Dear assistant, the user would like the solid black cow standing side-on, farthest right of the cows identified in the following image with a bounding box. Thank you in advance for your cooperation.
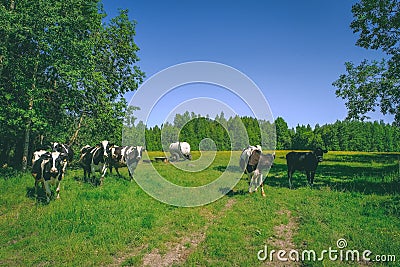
[286,148,328,188]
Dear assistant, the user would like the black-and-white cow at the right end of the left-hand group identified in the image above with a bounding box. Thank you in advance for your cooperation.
[109,146,144,181]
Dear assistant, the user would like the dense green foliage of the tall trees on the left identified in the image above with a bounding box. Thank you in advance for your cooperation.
[0,0,144,168]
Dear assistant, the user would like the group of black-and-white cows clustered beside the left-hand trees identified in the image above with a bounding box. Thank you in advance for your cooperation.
[31,140,144,202]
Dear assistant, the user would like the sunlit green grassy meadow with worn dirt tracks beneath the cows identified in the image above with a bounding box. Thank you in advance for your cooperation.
[0,151,400,266]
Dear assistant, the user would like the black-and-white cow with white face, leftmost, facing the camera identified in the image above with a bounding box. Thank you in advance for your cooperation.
[32,151,62,203]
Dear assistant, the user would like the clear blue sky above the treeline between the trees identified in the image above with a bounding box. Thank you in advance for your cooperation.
[103,0,393,130]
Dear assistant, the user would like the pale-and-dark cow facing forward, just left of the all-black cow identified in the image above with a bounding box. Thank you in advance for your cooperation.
[239,146,275,197]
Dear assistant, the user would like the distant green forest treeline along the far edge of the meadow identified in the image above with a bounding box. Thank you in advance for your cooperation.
[123,112,400,152]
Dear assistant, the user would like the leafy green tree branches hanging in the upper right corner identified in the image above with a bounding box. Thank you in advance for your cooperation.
[333,0,400,125]
